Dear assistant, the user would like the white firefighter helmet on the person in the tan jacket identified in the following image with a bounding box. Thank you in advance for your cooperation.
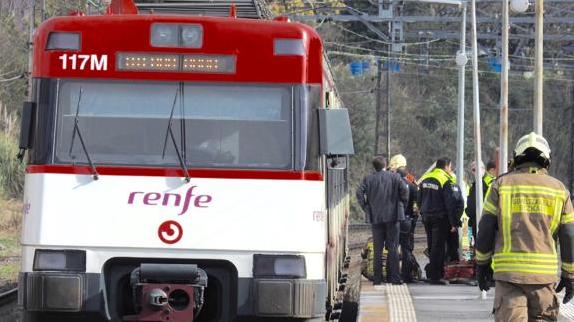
[514,132,550,168]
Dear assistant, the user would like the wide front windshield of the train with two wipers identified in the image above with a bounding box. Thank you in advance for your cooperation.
[54,80,294,169]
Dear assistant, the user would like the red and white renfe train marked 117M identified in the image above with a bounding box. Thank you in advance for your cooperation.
[19,0,353,322]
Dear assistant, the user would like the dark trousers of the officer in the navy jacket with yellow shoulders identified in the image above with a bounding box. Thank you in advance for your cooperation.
[425,217,450,280]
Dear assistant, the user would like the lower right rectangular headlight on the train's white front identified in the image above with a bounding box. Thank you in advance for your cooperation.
[253,254,307,278]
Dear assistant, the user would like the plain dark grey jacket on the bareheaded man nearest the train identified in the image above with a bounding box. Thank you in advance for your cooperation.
[357,171,409,224]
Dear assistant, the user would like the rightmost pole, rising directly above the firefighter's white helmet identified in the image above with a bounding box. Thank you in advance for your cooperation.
[534,0,544,135]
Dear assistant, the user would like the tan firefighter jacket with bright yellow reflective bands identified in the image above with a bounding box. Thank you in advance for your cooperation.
[476,164,574,284]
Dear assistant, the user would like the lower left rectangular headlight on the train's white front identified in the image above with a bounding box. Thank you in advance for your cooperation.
[34,249,86,272]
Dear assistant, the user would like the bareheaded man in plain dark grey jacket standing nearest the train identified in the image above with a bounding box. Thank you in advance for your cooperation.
[357,156,409,285]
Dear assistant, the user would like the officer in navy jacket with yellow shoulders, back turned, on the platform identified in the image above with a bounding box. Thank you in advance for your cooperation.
[418,158,464,284]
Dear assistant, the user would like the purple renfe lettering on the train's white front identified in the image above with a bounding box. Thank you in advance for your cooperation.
[128,186,213,215]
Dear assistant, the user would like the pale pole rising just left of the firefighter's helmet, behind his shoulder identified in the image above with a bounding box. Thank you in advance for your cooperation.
[498,0,510,173]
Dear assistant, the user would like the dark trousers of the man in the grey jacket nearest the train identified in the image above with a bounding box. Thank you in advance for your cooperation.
[372,222,400,284]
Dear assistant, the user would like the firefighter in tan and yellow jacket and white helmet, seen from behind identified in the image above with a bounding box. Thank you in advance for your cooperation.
[476,133,574,322]
